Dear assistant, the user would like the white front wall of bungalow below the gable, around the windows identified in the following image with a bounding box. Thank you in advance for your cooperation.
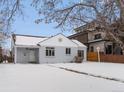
[39,47,87,64]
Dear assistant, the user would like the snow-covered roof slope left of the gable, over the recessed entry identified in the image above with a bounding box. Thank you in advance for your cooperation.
[15,35,47,46]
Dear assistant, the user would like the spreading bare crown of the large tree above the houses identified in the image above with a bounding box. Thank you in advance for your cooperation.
[32,0,119,27]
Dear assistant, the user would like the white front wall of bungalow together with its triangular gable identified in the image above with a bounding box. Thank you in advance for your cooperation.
[39,34,86,63]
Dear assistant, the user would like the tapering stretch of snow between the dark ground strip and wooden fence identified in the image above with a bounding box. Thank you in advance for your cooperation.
[52,62,124,83]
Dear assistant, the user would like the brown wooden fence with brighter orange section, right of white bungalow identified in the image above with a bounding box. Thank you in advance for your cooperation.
[87,52,124,63]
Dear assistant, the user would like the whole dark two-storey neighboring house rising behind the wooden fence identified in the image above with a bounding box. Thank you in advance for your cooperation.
[68,24,124,54]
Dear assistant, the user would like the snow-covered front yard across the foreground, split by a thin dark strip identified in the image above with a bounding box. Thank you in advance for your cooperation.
[0,63,124,92]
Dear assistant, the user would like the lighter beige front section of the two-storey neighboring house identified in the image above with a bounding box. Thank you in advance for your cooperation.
[88,31,114,54]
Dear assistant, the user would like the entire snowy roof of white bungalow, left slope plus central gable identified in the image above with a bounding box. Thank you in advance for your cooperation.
[15,33,86,47]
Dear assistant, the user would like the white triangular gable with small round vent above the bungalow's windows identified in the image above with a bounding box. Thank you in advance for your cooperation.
[39,33,86,47]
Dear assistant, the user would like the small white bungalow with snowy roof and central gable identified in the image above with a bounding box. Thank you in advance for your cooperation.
[12,34,87,64]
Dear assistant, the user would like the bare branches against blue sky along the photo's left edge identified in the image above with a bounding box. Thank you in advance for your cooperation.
[0,0,23,48]
